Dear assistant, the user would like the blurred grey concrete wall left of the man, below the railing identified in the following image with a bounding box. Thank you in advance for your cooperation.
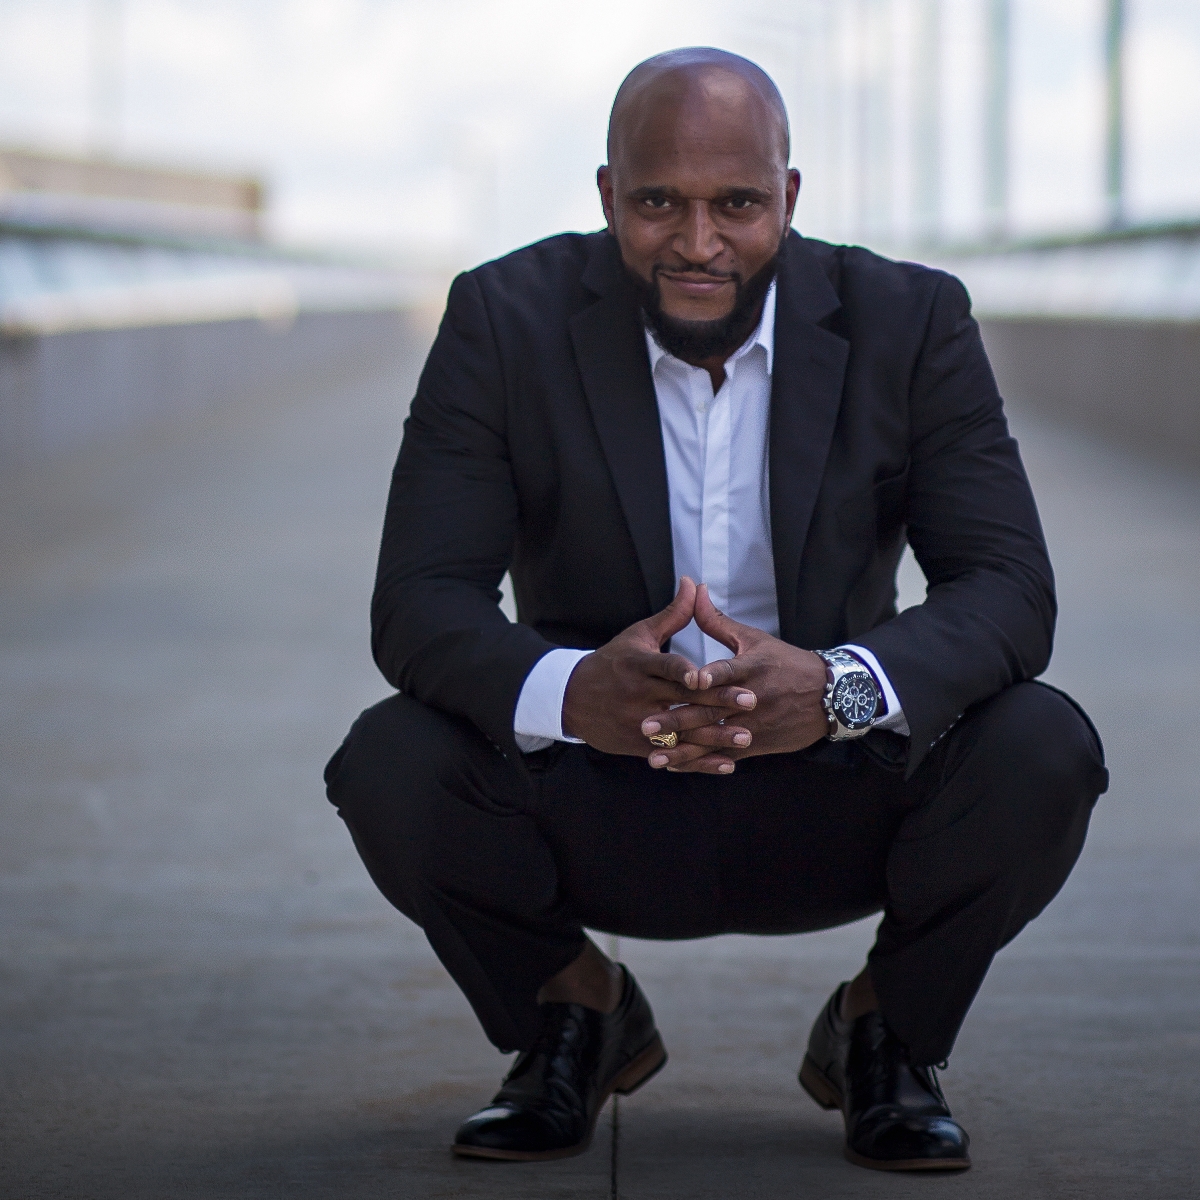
[0,312,417,469]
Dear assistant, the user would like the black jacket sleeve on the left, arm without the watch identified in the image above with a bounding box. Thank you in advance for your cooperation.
[371,275,553,760]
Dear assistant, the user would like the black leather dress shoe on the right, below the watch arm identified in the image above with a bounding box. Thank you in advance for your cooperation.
[800,984,971,1171]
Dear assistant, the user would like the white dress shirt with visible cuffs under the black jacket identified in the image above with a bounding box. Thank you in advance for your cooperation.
[512,283,908,754]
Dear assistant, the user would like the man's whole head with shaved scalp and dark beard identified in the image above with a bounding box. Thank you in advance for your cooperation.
[596,48,800,355]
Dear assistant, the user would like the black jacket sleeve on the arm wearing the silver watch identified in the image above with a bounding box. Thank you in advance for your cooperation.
[856,276,1057,774]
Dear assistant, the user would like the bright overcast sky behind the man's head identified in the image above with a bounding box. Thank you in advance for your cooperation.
[0,0,1200,266]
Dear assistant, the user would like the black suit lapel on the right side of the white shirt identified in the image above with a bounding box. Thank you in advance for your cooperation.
[769,234,850,641]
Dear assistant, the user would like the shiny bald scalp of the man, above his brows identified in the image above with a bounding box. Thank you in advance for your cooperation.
[608,46,791,168]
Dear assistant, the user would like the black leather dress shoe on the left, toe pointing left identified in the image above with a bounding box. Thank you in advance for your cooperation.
[452,966,667,1162]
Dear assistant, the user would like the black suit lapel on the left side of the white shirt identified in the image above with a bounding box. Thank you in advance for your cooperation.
[569,236,674,612]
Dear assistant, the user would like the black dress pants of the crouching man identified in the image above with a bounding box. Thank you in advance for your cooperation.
[325,683,1108,1063]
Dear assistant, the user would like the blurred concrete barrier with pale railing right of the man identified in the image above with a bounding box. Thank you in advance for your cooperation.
[935,223,1200,469]
